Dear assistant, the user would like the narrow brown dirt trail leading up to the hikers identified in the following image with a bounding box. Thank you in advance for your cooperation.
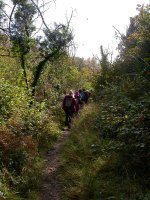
[41,131,69,200]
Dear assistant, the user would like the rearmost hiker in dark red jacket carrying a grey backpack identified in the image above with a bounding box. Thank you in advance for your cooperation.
[62,90,76,128]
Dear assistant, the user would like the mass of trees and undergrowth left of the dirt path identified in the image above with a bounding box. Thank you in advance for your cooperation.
[0,0,95,200]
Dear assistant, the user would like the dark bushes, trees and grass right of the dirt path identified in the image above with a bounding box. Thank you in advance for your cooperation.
[60,5,150,200]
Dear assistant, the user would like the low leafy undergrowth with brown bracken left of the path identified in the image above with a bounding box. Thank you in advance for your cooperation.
[0,80,60,200]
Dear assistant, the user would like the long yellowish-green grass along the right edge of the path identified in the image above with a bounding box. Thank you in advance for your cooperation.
[59,105,150,200]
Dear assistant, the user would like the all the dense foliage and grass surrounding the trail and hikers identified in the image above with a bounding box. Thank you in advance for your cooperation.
[0,0,150,200]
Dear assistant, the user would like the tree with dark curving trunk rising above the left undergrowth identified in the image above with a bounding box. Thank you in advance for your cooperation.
[0,0,73,96]
